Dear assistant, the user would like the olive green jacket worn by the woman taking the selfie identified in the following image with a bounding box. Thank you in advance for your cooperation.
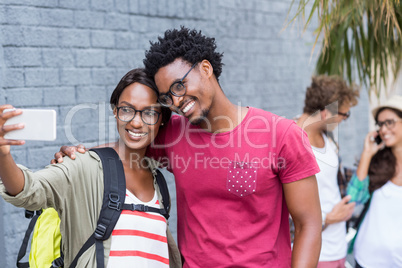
[0,151,181,267]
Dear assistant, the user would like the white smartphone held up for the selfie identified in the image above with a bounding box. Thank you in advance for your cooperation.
[4,109,56,141]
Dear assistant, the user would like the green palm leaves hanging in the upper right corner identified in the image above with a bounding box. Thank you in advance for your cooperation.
[291,0,402,96]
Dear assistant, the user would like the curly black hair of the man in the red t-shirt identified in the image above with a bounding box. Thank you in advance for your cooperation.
[143,26,223,80]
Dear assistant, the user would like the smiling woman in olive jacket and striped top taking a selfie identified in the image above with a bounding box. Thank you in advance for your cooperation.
[0,69,181,267]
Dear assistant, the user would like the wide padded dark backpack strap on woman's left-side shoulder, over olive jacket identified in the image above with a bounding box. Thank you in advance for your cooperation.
[70,147,126,268]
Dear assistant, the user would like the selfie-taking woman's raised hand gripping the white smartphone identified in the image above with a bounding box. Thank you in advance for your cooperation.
[0,104,25,155]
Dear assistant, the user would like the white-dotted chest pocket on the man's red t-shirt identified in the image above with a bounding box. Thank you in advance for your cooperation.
[226,161,258,197]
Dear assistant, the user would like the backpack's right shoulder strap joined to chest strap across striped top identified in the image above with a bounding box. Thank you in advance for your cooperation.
[122,169,170,220]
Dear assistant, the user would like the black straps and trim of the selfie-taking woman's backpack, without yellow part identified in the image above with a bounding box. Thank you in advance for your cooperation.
[17,147,170,268]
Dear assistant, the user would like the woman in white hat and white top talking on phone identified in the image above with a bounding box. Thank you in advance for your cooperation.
[348,96,402,268]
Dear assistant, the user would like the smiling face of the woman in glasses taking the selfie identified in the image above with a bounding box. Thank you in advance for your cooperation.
[113,82,162,153]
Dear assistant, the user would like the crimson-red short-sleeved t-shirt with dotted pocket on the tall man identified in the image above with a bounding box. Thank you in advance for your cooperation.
[149,107,319,268]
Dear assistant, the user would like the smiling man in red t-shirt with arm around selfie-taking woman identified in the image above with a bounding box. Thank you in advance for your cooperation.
[55,27,321,268]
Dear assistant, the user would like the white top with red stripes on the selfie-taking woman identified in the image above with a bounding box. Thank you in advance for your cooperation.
[107,190,169,268]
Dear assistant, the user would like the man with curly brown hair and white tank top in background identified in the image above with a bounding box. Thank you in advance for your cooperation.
[297,75,359,268]
